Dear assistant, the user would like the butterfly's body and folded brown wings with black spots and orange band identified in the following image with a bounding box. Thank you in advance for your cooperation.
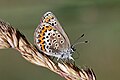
[34,12,74,60]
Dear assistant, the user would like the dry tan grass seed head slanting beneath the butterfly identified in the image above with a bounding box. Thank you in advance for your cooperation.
[0,20,96,80]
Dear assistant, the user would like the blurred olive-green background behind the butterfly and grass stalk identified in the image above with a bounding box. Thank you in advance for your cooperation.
[0,0,120,80]
